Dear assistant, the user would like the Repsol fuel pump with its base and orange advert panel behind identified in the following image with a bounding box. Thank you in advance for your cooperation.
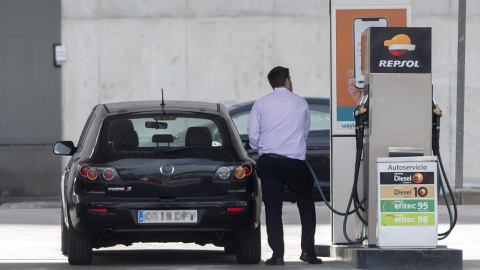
[322,0,462,269]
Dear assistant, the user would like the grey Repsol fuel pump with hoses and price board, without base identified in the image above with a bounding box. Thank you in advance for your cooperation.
[310,27,457,247]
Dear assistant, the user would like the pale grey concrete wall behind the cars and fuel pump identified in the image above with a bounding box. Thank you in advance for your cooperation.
[62,0,480,186]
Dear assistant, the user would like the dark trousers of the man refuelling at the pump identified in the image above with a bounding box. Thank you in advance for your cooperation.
[257,155,316,258]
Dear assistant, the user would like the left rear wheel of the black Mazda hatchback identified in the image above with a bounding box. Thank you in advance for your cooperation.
[68,223,92,265]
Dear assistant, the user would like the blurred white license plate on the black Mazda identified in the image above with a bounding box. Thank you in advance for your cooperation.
[138,210,197,223]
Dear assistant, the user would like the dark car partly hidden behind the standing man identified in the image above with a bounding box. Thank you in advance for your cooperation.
[229,98,330,202]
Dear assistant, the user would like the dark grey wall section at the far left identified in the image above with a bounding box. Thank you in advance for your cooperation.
[0,0,63,199]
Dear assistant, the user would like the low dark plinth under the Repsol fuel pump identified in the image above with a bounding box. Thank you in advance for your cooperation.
[330,245,463,270]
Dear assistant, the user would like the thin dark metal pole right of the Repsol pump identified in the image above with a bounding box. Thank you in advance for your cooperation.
[455,0,467,188]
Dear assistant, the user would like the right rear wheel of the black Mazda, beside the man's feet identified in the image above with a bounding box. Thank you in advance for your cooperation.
[237,225,262,264]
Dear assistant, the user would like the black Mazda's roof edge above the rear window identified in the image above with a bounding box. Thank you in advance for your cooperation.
[103,100,226,113]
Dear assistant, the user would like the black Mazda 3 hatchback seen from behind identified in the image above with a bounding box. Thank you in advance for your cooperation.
[53,101,262,264]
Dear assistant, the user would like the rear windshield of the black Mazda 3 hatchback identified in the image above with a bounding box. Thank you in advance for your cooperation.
[100,113,229,158]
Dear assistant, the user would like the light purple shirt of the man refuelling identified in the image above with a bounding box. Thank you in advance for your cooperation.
[248,88,310,160]
